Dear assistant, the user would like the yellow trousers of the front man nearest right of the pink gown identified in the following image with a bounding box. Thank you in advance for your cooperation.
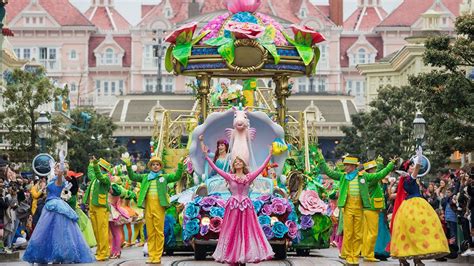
[341,195,363,264]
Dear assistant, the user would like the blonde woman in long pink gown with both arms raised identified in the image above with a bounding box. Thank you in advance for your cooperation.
[206,143,275,264]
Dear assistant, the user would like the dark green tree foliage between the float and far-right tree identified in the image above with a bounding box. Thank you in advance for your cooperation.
[337,86,417,161]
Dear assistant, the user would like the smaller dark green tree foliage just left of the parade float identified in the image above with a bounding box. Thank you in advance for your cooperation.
[67,108,126,173]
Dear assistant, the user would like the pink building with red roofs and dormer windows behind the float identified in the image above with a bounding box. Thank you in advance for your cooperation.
[3,0,463,112]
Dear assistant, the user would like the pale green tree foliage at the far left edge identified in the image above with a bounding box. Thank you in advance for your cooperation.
[0,67,64,158]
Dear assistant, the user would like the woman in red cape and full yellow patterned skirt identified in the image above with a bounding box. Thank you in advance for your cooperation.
[390,147,449,266]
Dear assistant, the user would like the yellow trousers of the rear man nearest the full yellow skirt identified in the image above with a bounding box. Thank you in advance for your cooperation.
[362,210,380,259]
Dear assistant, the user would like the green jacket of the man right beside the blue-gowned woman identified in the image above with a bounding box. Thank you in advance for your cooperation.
[84,164,110,208]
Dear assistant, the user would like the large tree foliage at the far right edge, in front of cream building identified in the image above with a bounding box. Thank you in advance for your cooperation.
[410,15,474,166]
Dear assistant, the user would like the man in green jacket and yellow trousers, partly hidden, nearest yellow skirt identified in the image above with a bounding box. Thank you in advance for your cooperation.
[362,158,385,262]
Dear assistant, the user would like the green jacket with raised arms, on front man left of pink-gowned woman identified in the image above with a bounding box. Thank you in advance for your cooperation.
[127,162,184,209]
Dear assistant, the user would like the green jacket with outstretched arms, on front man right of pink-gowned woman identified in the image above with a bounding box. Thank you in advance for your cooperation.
[316,155,393,208]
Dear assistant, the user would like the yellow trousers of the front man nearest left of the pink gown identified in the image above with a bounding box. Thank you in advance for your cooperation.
[145,195,165,263]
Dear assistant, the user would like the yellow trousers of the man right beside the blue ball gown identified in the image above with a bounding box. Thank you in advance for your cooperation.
[89,204,110,261]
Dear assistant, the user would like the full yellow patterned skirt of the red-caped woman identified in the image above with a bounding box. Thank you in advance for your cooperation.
[390,197,449,259]
